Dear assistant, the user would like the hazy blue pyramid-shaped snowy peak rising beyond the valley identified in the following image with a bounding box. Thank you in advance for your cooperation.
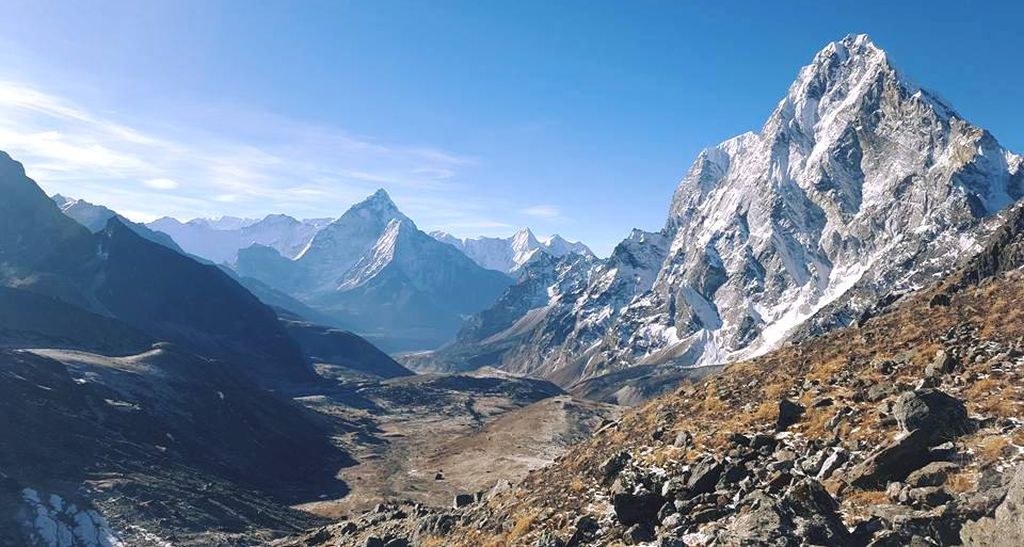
[236,190,511,350]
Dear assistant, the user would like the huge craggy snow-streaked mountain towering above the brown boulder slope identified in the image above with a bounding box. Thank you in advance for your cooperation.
[415,35,1024,391]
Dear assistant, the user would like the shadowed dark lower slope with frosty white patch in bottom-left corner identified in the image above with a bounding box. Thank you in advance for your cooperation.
[0,344,351,547]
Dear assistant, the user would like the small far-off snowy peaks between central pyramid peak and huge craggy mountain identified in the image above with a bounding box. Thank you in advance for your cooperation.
[430,227,594,274]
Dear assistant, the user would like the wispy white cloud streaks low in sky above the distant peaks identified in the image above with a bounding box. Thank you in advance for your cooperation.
[0,81,520,235]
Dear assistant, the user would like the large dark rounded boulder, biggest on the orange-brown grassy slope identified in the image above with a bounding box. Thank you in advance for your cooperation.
[893,389,970,446]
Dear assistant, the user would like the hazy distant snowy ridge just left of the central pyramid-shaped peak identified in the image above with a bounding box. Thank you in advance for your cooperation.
[146,214,331,263]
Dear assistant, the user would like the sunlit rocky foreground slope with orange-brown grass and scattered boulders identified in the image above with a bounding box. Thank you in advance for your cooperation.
[283,203,1024,546]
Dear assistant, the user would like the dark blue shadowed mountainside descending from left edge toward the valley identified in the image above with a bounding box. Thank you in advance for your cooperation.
[0,154,315,386]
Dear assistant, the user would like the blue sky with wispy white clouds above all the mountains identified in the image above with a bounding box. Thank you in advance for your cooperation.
[0,0,1024,254]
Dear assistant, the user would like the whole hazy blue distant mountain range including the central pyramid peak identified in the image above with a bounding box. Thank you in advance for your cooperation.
[141,197,593,350]
